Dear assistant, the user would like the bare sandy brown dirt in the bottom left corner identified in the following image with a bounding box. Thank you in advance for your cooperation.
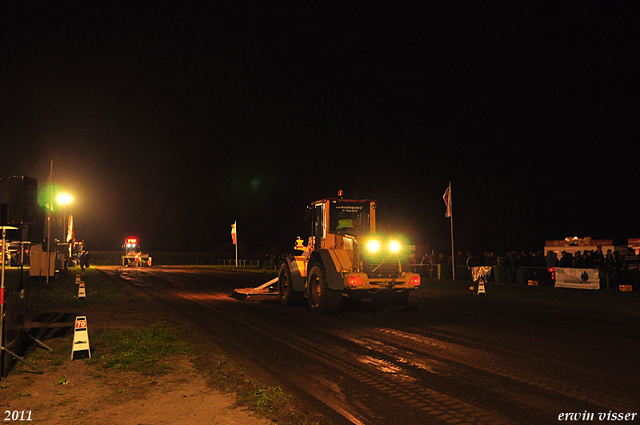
[0,360,272,425]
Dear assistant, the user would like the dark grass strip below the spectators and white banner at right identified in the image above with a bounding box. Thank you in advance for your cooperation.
[421,279,640,317]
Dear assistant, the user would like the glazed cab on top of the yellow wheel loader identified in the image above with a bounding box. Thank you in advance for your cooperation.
[311,198,376,249]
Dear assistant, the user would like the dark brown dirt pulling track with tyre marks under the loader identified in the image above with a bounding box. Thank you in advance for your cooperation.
[100,269,640,424]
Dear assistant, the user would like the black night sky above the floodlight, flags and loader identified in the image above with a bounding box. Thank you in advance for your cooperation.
[0,0,640,257]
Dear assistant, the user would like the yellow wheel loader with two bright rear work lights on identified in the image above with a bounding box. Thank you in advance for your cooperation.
[274,192,420,314]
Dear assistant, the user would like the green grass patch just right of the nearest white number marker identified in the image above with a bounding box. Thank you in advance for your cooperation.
[87,322,191,375]
